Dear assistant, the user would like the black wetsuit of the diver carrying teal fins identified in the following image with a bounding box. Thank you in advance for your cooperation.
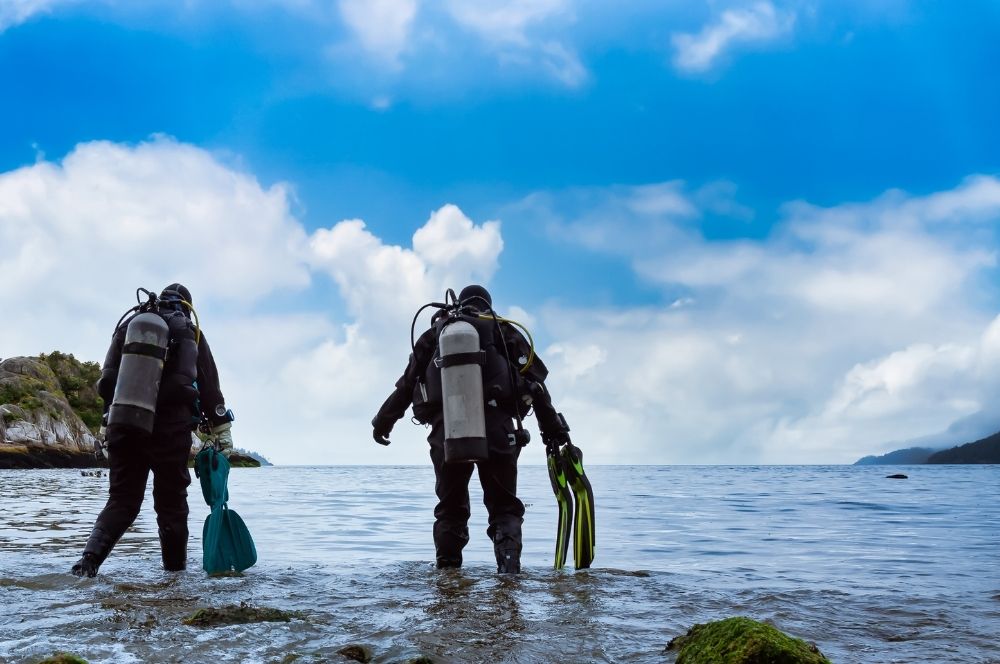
[84,324,228,570]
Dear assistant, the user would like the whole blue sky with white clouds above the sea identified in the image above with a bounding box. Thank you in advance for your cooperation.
[0,0,1000,464]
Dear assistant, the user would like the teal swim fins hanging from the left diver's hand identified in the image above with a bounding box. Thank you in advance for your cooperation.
[194,447,257,574]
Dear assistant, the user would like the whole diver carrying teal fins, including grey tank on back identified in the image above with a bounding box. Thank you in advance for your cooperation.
[72,283,233,577]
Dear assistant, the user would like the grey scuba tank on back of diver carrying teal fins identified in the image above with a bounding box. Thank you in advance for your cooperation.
[108,312,170,433]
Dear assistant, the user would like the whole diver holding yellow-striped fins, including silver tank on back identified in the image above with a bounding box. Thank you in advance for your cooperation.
[372,285,584,574]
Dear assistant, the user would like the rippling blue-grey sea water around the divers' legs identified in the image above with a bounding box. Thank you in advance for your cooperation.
[0,463,1000,664]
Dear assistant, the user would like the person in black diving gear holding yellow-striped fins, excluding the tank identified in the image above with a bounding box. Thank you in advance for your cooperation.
[372,285,568,573]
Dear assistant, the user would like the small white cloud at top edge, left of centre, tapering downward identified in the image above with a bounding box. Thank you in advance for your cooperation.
[338,0,418,66]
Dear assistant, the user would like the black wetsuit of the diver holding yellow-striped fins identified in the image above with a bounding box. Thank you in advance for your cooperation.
[372,324,547,572]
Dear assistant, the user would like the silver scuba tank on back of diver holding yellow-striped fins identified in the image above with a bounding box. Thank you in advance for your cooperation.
[438,320,489,463]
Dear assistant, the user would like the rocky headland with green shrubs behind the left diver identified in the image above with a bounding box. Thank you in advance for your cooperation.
[0,351,272,469]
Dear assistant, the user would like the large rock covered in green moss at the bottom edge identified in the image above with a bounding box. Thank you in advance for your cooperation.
[666,617,830,664]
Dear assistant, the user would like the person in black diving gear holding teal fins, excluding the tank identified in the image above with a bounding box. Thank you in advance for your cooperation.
[72,283,233,577]
